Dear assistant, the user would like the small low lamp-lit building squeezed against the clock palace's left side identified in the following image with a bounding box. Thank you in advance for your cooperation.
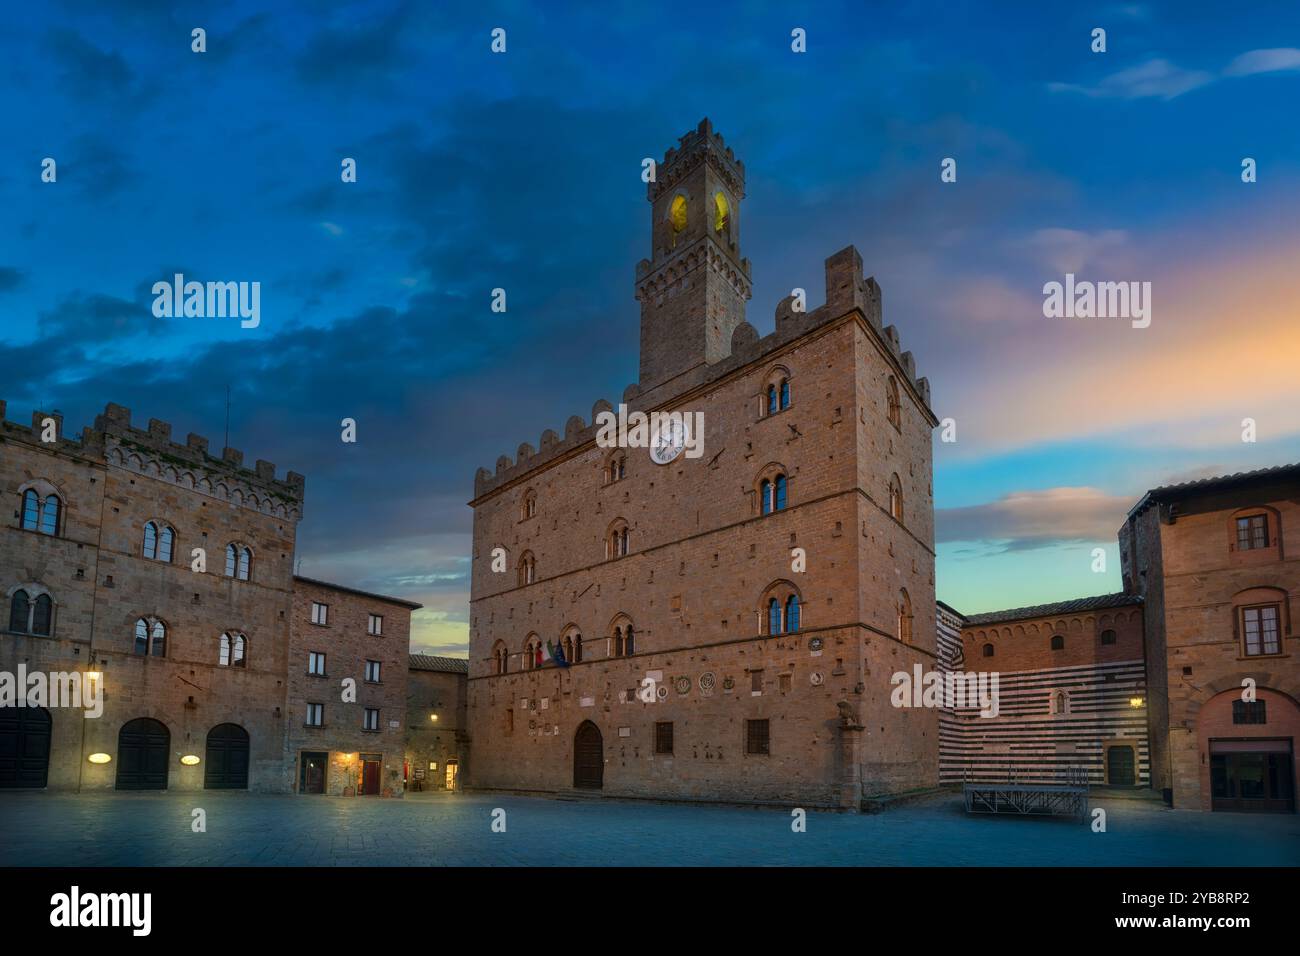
[406,654,469,791]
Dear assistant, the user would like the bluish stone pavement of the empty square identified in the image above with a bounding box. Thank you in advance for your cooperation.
[0,792,1300,866]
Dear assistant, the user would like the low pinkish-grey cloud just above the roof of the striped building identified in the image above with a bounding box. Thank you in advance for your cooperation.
[935,488,1136,550]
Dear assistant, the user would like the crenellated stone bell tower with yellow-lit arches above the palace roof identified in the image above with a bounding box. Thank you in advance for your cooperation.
[637,118,750,390]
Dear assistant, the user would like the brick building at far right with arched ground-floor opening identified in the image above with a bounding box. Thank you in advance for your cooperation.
[1119,466,1300,810]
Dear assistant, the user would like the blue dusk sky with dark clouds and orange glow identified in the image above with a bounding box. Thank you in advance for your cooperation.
[0,0,1300,656]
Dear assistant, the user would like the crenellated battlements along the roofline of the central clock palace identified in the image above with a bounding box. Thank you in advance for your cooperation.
[475,244,937,499]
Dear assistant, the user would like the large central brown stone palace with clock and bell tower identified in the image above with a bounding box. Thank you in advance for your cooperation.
[469,120,939,806]
